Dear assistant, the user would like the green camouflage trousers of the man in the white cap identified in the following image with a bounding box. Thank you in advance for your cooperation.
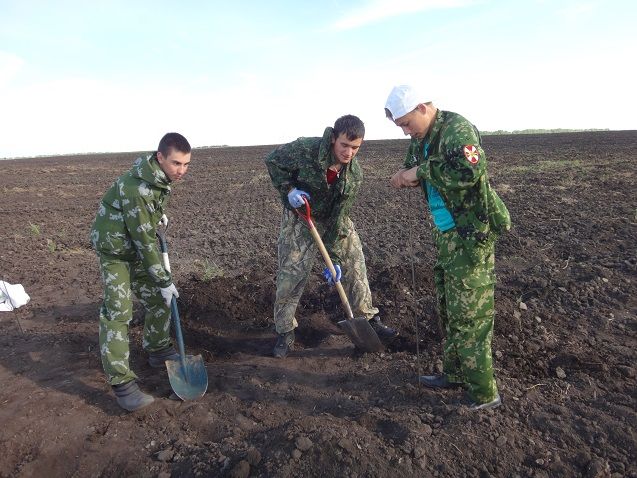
[433,228,497,403]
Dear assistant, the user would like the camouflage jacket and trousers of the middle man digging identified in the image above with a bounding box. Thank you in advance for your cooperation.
[265,128,378,334]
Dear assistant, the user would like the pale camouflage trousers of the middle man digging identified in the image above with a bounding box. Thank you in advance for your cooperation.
[274,209,378,334]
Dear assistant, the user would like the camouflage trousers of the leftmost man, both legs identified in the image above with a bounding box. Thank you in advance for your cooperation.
[97,253,171,385]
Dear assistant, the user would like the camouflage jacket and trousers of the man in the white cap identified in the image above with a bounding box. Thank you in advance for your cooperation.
[405,110,511,403]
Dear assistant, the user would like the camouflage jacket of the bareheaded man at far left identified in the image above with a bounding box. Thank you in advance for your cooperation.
[90,153,172,287]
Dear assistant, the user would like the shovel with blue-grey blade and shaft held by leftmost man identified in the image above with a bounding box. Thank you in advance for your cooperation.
[157,231,208,400]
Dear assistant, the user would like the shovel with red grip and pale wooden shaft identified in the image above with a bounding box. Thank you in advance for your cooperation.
[295,197,385,352]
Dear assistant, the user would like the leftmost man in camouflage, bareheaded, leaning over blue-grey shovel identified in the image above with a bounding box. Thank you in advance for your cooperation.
[91,133,191,411]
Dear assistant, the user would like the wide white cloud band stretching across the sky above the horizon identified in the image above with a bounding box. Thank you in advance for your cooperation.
[0,20,637,158]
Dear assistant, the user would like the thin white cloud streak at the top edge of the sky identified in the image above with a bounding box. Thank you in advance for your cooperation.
[331,0,474,30]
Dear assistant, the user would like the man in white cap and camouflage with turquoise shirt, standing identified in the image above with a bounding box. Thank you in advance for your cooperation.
[385,85,511,410]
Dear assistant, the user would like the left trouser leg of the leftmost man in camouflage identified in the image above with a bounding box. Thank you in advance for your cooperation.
[98,254,137,385]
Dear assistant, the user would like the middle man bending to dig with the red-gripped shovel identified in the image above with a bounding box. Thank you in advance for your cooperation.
[265,115,397,358]
